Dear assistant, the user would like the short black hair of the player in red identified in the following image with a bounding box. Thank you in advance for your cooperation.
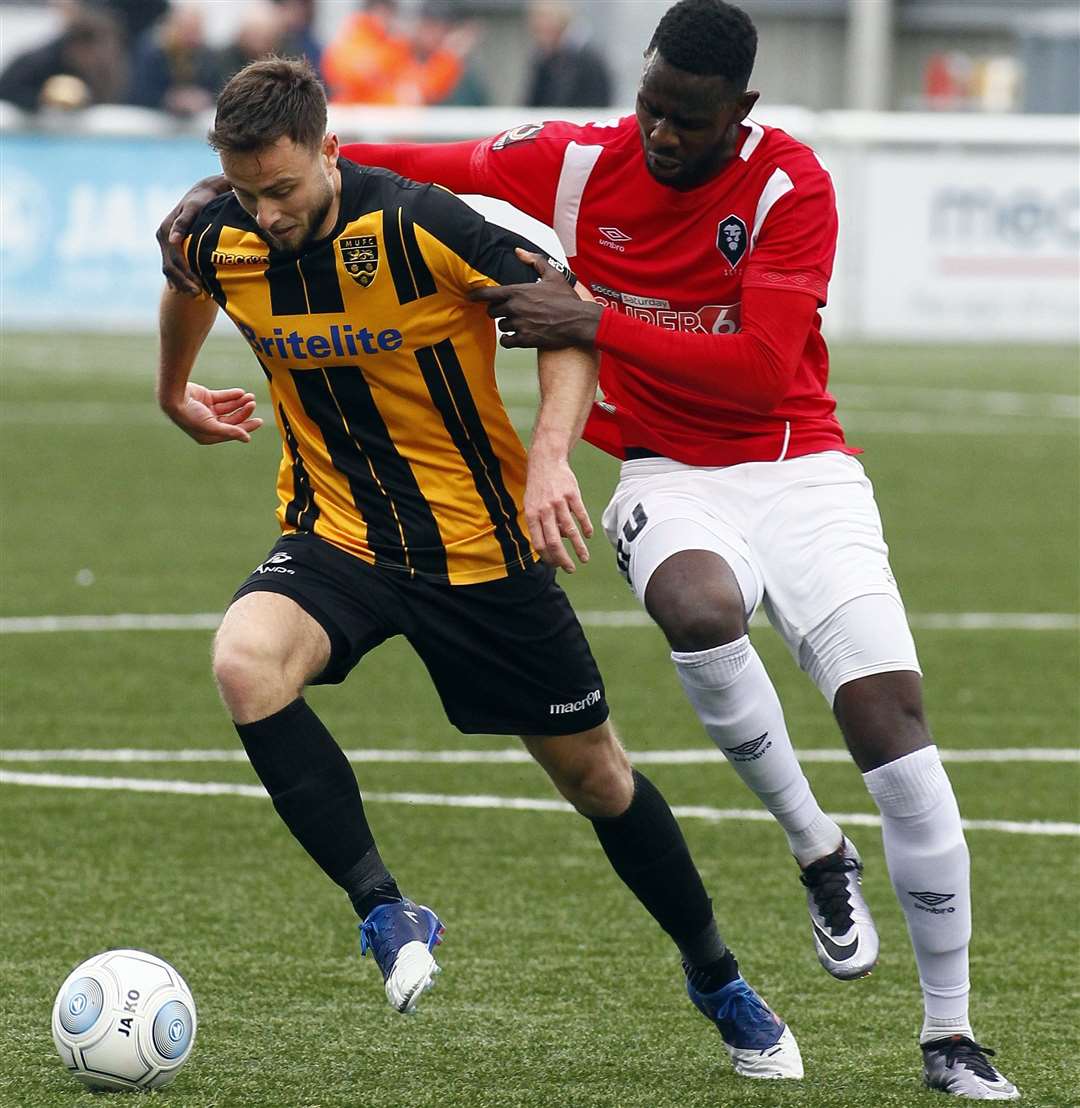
[647,0,758,92]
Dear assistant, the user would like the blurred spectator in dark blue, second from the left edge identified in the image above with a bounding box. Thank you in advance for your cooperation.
[127,2,224,116]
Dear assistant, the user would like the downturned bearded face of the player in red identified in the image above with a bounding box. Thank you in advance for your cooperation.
[637,50,758,189]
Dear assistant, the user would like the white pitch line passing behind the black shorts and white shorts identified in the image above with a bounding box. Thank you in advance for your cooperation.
[0,608,1080,635]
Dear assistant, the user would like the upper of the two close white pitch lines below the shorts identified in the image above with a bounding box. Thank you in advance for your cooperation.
[0,747,1080,766]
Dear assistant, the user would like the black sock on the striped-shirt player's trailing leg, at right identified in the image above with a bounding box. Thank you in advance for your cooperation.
[592,770,727,966]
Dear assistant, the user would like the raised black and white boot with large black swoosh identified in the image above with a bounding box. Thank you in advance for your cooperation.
[799,835,878,981]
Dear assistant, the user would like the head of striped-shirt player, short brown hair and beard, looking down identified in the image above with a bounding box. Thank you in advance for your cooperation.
[209,58,339,250]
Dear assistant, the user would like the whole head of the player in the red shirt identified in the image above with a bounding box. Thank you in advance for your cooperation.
[637,0,758,188]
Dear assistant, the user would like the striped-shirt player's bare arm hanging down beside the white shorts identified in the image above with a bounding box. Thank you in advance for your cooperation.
[517,249,597,573]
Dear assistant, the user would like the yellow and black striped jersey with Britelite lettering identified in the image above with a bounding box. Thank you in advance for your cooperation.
[186,160,549,584]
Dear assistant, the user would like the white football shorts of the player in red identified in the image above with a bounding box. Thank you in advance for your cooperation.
[603,451,922,706]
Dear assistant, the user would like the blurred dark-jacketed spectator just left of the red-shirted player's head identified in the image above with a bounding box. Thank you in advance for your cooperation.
[525,0,611,107]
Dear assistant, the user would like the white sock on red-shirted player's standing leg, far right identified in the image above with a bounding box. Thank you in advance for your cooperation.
[863,747,973,1043]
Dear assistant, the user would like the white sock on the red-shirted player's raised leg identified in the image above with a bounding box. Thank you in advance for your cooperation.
[671,635,843,865]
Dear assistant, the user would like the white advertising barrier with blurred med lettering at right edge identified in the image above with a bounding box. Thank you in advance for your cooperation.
[851,150,1080,340]
